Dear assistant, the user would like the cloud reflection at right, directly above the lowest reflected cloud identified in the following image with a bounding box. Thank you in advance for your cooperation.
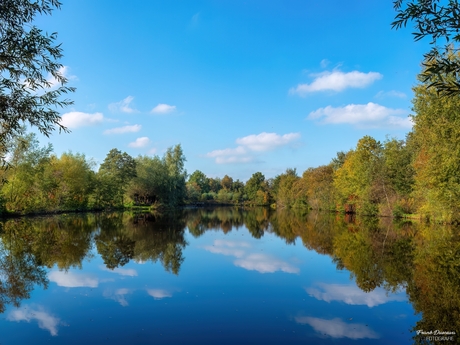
[305,284,405,308]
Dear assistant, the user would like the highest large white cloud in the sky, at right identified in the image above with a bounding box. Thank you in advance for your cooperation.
[289,70,383,96]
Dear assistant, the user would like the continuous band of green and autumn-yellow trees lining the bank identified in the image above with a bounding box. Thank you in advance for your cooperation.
[0,67,460,223]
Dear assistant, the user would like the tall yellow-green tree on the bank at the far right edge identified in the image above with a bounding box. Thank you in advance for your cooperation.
[413,77,460,222]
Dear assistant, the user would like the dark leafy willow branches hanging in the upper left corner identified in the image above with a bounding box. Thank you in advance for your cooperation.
[0,0,74,163]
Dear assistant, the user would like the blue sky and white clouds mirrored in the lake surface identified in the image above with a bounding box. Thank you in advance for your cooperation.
[0,208,448,344]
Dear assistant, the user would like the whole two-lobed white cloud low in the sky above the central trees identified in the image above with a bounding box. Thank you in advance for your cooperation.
[206,132,300,164]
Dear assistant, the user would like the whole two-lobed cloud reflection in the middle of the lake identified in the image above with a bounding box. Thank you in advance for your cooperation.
[204,240,300,273]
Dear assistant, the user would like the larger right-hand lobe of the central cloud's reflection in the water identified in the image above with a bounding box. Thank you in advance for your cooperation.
[234,254,299,273]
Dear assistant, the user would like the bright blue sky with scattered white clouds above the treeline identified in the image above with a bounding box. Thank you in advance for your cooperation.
[36,0,428,181]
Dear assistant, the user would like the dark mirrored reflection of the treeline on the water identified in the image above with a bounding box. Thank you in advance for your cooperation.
[0,208,460,342]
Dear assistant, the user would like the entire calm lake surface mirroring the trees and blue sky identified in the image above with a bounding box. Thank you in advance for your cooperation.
[0,208,460,345]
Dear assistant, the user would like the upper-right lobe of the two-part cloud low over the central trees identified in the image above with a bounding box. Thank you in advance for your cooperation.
[236,132,300,151]
